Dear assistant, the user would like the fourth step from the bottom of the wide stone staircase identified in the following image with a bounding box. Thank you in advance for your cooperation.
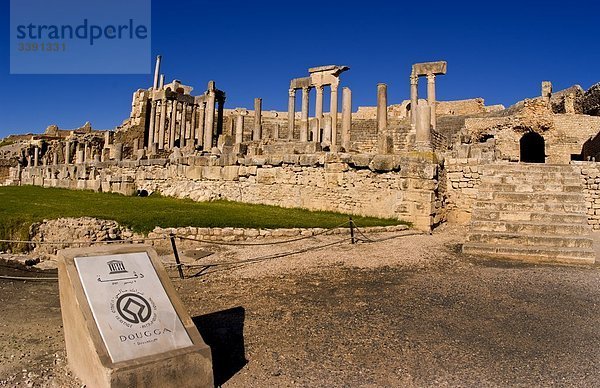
[472,208,587,225]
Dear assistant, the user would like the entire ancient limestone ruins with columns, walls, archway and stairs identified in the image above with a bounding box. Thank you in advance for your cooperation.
[0,56,600,261]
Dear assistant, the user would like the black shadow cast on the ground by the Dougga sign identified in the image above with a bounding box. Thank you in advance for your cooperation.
[192,306,247,386]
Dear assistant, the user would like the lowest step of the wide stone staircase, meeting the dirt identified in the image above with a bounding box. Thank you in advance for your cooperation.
[462,243,596,264]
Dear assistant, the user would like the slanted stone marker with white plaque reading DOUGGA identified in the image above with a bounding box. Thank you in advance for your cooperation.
[59,246,213,387]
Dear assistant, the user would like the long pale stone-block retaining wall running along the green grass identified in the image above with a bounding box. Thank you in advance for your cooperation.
[11,153,442,230]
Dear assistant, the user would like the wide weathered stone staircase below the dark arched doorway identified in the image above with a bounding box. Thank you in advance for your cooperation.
[463,163,595,263]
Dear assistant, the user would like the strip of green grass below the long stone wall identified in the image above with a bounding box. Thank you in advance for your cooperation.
[0,186,406,246]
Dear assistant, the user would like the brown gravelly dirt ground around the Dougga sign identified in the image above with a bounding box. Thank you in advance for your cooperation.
[0,229,600,387]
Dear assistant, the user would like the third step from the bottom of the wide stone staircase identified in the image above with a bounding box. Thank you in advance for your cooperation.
[471,221,590,237]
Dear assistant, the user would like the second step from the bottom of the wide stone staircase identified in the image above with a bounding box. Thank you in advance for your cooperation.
[467,232,593,249]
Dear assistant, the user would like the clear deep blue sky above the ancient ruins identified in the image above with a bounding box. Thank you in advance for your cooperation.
[0,0,600,137]
